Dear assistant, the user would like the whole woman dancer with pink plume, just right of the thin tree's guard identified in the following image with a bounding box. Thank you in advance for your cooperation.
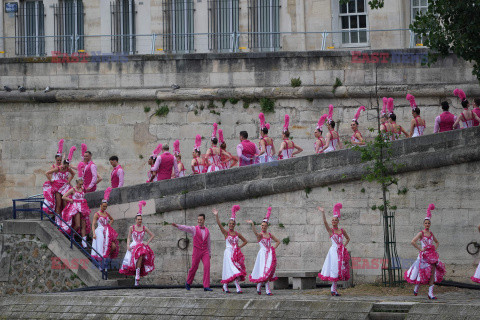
[404,203,446,299]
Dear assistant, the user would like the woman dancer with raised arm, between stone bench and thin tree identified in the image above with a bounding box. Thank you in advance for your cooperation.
[318,203,350,296]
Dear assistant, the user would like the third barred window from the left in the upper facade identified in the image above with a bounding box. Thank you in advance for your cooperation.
[110,0,135,54]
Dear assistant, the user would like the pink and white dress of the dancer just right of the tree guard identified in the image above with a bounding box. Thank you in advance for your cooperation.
[403,230,446,284]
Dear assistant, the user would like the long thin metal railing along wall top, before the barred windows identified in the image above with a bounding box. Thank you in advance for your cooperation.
[0,29,422,58]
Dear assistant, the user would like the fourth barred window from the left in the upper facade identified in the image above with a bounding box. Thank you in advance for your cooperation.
[163,0,194,53]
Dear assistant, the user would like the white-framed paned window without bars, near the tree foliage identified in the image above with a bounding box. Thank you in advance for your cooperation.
[339,0,368,44]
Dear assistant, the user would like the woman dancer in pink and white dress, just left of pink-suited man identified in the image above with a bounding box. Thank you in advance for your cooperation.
[118,201,155,286]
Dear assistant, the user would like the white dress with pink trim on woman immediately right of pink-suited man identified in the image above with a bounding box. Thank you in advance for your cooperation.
[220,231,247,283]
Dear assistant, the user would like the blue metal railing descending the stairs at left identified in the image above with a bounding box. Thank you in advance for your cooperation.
[12,194,108,280]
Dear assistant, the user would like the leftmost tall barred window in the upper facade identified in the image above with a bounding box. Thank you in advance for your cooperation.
[15,1,45,56]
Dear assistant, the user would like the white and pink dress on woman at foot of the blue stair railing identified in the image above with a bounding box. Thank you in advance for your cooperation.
[92,212,119,260]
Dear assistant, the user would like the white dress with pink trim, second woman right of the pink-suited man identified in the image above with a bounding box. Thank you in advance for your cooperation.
[249,234,278,283]
